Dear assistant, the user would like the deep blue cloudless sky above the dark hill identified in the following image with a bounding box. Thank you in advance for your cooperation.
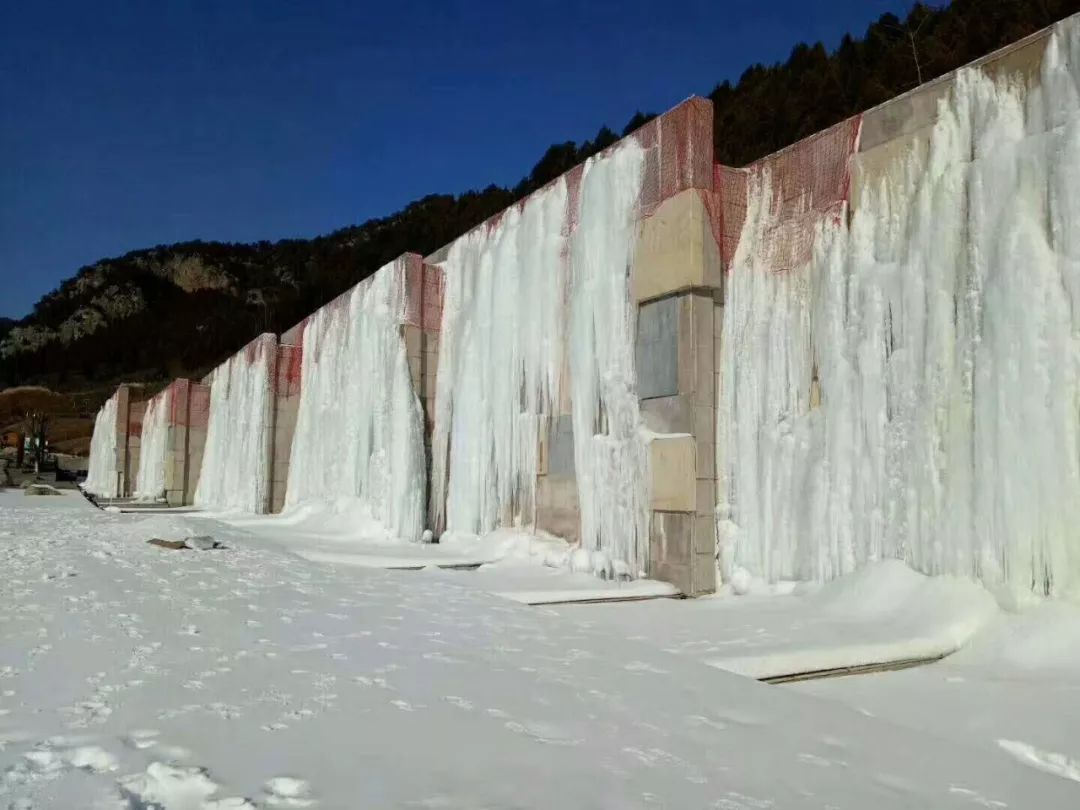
[0,0,907,316]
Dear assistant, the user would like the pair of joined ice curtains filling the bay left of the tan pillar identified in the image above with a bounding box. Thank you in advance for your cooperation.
[432,140,648,572]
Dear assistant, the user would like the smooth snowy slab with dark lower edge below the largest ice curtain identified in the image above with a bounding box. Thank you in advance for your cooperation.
[552,561,998,678]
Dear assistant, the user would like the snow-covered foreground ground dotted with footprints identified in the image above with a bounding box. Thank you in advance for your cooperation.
[0,494,1080,810]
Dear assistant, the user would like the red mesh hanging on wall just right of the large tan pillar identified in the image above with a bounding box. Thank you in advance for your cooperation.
[714,117,862,270]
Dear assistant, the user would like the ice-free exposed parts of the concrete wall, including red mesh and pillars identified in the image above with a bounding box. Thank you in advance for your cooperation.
[84,11,1071,594]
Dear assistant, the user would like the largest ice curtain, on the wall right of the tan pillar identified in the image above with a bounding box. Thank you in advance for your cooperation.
[717,19,1080,598]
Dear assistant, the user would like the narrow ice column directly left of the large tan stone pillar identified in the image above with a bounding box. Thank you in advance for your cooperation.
[569,141,649,575]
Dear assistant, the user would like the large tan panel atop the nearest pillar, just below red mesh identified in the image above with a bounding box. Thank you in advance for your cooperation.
[631,189,723,302]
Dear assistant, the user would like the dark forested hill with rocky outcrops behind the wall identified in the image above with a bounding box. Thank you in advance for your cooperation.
[0,0,1080,391]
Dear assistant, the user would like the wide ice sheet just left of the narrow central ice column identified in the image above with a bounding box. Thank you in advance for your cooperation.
[432,178,568,534]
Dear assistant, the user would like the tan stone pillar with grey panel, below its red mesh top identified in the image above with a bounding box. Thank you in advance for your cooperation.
[632,188,724,596]
